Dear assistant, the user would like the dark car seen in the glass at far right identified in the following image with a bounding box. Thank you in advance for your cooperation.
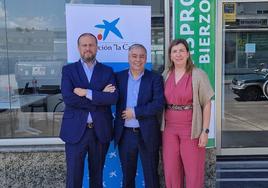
[231,64,268,101]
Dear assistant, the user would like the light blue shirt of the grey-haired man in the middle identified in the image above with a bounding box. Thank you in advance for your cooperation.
[125,71,144,127]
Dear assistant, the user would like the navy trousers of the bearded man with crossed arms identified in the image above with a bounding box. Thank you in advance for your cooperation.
[65,128,110,188]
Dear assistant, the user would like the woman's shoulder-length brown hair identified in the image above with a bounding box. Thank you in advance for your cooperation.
[168,39,194,73]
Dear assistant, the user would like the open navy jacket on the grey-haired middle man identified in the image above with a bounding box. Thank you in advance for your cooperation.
[114,70,164,150]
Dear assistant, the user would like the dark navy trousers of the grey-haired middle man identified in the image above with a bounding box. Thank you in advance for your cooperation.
[118,129,159,188]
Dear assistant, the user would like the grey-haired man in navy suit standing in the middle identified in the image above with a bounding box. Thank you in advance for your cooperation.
[114,44,164,188]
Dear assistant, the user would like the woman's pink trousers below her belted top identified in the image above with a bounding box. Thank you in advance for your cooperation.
[162,125,205,188]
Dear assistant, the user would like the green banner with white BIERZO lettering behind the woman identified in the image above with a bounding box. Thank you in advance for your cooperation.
[173,0,216,147]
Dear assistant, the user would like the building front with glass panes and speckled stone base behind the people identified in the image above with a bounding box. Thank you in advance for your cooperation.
[0,0,268,187]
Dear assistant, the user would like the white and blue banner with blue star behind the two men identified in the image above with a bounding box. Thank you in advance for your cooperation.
[66,4,152,188]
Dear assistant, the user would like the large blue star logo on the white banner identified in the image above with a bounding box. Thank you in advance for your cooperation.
[95,18,123,40]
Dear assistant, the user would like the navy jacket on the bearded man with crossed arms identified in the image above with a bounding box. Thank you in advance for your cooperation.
[60,61,118,143]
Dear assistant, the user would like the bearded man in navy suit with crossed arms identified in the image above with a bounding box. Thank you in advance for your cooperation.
[60,33,118,188]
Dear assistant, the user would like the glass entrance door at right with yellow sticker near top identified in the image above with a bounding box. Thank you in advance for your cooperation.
[216,0,268,155]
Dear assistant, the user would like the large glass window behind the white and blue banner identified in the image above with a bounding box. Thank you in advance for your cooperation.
[0,0,164,138]
